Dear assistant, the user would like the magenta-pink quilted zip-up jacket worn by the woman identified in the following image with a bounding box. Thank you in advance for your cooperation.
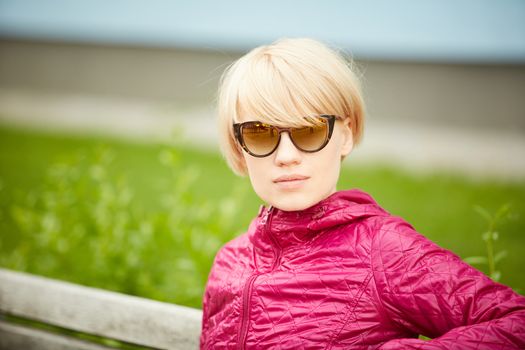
[201,190,525,349]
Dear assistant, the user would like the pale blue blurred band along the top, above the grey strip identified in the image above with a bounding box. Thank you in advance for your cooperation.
[0,0,525,64]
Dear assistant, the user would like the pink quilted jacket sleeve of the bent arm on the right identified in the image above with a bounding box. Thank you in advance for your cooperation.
[371,217,525,350]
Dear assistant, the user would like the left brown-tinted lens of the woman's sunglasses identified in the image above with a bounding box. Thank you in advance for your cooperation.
[241,123,279,156]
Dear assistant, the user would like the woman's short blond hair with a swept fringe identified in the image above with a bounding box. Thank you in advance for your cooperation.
[217,38,365,176]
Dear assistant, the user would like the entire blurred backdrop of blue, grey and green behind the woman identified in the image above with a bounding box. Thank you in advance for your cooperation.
[0,0,525,307]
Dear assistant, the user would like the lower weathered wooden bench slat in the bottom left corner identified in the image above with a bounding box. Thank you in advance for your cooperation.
[0,321,111,350]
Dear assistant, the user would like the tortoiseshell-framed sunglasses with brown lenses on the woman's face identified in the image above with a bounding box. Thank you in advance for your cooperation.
[233,115,336,158]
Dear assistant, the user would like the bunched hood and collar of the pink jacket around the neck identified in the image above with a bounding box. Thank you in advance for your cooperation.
[250,189,389,247]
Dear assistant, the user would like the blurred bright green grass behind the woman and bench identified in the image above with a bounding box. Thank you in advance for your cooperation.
[0,126,525,307]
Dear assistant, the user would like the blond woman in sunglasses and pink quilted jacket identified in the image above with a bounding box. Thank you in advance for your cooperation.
[201,39,525,349]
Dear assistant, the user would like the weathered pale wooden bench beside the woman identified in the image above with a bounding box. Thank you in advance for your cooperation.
[0,269,202,350]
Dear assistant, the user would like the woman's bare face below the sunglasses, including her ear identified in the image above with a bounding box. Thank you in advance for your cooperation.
[243,119,353,211]
